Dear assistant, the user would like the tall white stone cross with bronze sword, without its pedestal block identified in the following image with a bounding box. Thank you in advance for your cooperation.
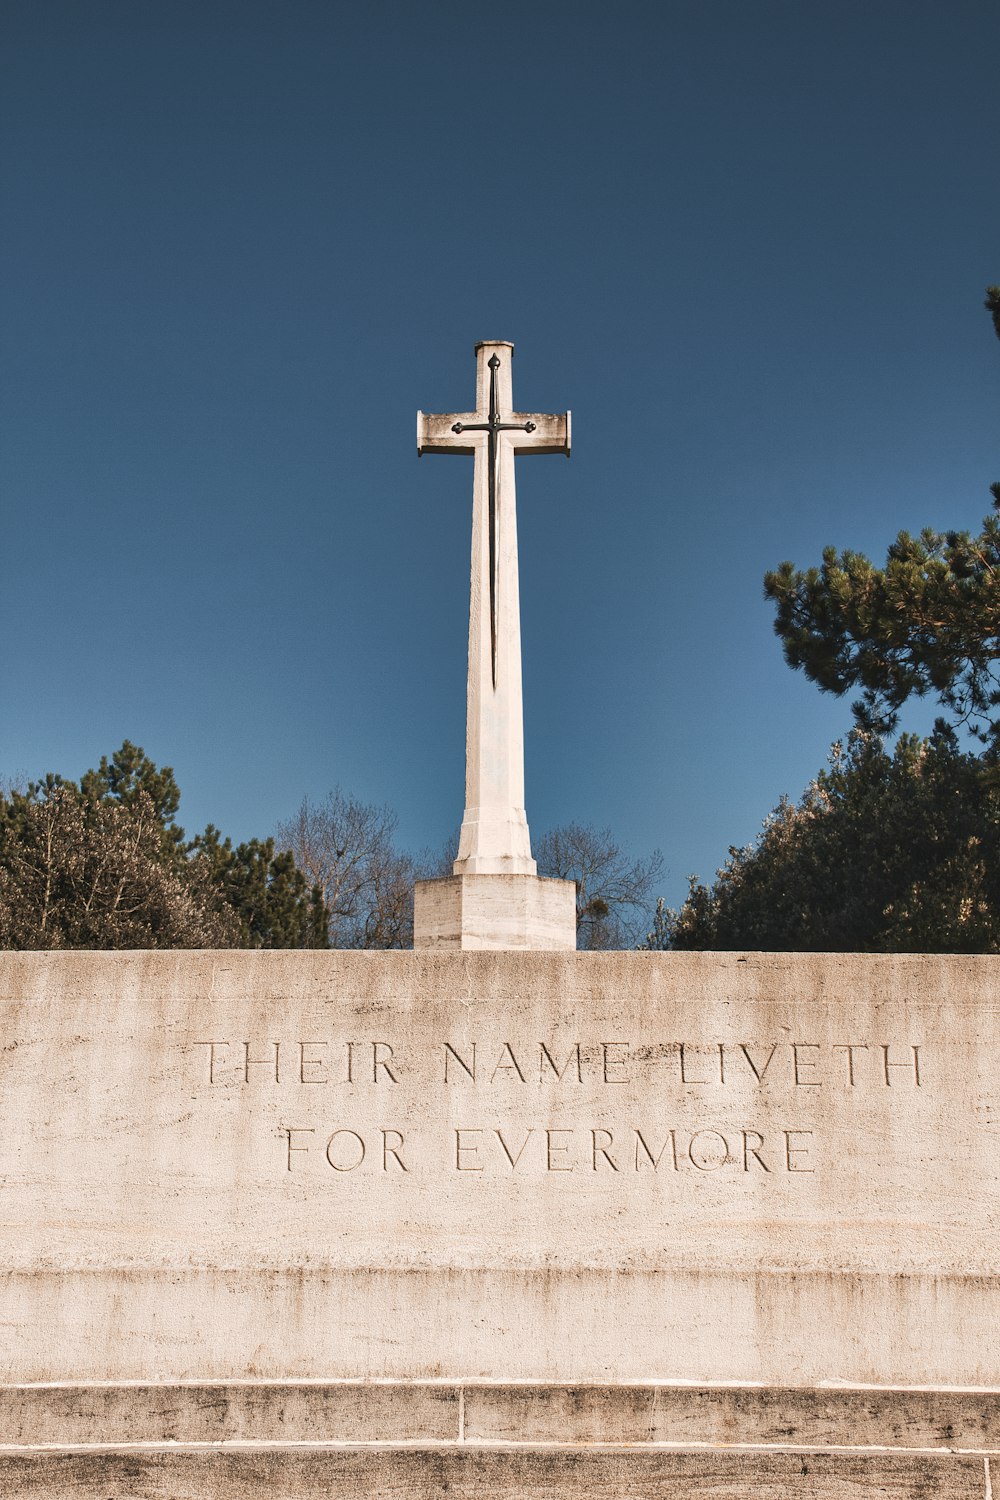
[417,341,570,875]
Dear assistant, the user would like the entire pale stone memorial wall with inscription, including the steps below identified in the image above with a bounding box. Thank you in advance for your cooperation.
[0,953,1000,1497]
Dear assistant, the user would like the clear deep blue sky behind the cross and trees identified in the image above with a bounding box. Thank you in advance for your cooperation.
[0,0,1000,905]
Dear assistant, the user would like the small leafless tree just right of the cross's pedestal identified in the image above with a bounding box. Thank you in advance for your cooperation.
[535,824,663,950]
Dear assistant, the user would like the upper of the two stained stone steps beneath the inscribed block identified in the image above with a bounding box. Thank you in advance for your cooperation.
[0,1380,1000,1457]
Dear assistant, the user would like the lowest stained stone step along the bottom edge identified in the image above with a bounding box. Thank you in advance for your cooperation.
[0,1449,988,1500]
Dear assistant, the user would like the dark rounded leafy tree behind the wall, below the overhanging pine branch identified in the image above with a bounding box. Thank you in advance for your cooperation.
[665,726,1000,953]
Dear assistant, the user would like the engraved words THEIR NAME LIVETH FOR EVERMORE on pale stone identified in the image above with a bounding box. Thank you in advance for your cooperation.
[189,1028,934,1191]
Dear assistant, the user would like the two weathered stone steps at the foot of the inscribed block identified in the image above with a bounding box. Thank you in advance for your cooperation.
[0,1380,1000,1500]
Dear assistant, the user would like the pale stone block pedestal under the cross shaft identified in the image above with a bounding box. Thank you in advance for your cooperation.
[414,875,576,951]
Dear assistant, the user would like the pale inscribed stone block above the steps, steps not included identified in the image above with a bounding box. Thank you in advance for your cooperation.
[0,953,1000,1388]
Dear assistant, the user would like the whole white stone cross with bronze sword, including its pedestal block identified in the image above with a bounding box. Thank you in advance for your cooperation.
[414,341,576,948]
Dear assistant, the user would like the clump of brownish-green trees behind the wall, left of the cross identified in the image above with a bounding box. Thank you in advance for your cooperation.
[0,740,327,948]
